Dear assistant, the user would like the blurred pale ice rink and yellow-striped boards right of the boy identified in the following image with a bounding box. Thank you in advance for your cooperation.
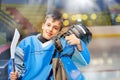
[82,26,120,80]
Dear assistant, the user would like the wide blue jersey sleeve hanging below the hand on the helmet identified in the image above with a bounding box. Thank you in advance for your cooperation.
[72,40,90,66]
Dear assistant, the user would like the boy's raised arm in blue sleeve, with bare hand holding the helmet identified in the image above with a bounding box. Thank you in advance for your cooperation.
[65,34,90,65]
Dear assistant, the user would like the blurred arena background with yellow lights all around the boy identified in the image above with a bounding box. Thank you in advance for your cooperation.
[0,0,120,80]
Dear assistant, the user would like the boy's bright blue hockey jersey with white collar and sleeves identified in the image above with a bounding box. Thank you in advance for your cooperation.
[7,35,90,80]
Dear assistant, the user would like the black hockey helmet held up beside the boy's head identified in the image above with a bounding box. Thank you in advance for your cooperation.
[64,24,92,44]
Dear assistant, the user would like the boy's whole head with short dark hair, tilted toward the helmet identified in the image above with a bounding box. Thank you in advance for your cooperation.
[42,10,63,40]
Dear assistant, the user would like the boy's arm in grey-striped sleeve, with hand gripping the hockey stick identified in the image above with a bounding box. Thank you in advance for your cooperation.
[8,47,25,80]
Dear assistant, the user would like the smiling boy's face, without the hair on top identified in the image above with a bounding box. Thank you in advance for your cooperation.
[42,18,61,40]
